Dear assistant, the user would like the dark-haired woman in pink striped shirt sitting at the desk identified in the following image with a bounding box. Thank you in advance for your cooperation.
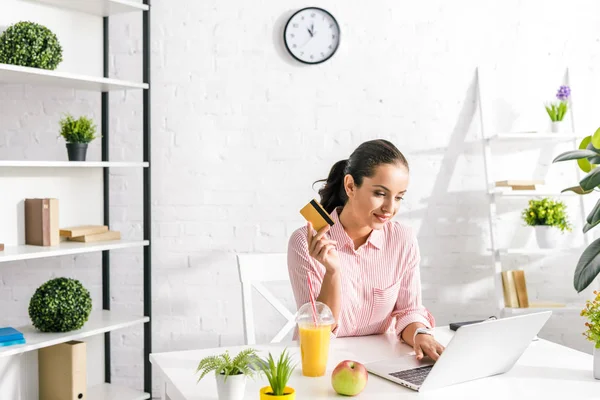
[288,140,444,360]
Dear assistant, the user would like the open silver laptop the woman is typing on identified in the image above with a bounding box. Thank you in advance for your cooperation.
[365,311,552,392]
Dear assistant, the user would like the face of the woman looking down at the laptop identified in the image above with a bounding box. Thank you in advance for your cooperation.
[344,164,409,229]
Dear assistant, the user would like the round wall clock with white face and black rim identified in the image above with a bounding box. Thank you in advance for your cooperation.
[283,7,340,64]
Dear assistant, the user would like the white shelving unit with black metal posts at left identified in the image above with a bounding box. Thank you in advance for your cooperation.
[0,0,152,400]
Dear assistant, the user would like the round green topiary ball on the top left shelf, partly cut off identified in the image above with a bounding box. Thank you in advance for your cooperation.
[0,21,62,70]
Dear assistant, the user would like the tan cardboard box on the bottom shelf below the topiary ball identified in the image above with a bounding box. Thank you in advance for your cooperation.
[38,340,87,400]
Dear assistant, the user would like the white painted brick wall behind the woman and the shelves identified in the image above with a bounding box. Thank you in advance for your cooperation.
[0,0,600,396]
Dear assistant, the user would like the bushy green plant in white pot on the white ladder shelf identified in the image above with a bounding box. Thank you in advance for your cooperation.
[522,198,571,249]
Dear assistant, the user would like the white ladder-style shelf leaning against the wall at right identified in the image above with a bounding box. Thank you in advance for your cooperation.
[477,67,589,315]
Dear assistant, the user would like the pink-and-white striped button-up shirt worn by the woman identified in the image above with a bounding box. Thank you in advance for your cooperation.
[288,210,435,337]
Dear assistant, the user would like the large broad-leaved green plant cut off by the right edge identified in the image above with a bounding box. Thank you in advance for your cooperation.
[553,129,600,292]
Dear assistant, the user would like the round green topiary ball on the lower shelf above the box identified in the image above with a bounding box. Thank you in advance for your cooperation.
[29,278,92,332]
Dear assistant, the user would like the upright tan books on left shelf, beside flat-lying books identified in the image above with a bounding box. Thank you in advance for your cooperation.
[25,199,60,246]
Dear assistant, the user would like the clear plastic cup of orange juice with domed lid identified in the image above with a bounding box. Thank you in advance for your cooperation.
[296,301,335,376]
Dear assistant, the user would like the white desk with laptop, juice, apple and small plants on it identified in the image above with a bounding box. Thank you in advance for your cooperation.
[150,327,600,400]
